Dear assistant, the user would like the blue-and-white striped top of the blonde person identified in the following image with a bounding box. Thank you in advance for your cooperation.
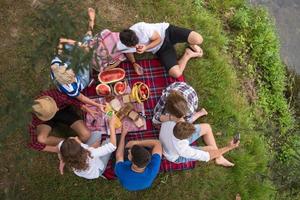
[50,57,84,97]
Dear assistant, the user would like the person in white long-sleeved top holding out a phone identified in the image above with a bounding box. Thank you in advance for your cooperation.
[159,121,239,167]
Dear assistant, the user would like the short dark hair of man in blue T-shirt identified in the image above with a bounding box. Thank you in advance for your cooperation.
[131,145,151,168]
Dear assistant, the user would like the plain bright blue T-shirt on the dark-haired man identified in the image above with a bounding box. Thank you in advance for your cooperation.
[115,154,161,191]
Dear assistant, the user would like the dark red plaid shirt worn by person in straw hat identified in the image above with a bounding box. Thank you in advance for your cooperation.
[28,89,83,151]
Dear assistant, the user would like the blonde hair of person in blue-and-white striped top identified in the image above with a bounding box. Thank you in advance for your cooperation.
[51,64,76,84]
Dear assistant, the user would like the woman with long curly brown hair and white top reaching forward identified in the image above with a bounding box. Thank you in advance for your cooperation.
[58,116,117,179]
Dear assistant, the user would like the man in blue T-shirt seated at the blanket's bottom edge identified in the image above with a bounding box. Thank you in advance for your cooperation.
[115,129,162,191]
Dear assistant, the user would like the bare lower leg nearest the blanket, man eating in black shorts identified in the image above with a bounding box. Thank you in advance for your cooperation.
[169,48,201,78]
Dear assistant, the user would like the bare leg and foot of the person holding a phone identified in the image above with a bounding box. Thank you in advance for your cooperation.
[200,124,234,167]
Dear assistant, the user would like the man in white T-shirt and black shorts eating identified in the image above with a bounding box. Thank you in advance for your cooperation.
[117,22,203,78]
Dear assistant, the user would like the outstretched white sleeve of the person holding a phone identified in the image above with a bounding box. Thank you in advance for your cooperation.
[176,140,210,162]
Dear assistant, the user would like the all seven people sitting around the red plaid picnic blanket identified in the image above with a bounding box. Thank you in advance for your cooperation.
[29,8,239,191]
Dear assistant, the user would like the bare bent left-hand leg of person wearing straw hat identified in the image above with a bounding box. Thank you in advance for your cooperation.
[36,124,63,146]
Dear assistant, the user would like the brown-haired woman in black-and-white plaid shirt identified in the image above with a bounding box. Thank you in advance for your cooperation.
[152,82,207,124]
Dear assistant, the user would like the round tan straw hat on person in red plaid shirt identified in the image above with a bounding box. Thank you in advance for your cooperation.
[32,96,58,121]
